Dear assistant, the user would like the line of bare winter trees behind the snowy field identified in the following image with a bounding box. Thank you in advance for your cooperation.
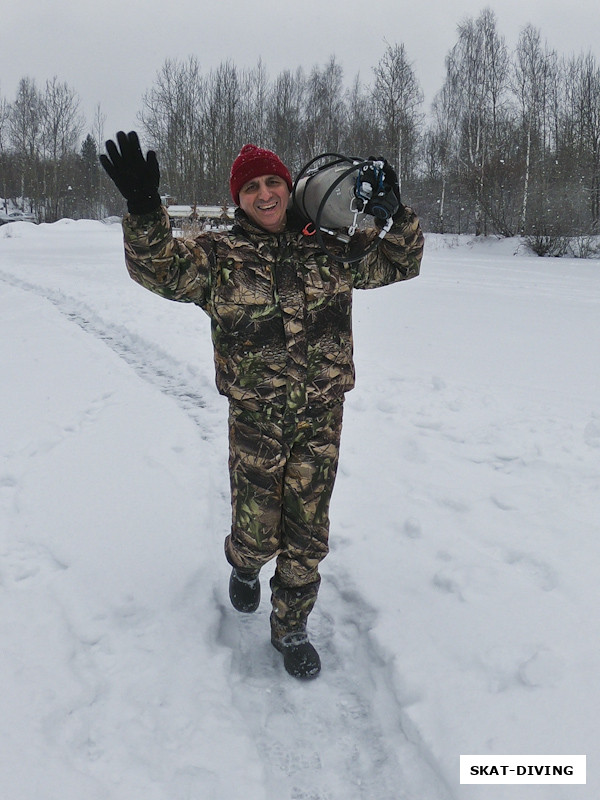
[0,8,600,251]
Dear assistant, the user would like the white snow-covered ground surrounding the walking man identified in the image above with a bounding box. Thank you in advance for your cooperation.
[0,220,600,800]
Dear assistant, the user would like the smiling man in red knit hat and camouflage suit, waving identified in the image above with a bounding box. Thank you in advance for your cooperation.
[100,131,423,678]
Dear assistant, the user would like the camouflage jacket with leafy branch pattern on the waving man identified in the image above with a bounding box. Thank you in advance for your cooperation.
[123,208,423,411]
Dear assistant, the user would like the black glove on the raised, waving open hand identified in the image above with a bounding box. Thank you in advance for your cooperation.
[100,131,160,214]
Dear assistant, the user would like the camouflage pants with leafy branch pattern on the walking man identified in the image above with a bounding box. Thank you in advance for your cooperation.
[225,402,343,637]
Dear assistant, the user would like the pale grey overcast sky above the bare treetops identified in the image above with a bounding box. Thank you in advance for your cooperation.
[0,0,600,142]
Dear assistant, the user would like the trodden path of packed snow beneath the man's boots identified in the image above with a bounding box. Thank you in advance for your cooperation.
[215,575,451,800]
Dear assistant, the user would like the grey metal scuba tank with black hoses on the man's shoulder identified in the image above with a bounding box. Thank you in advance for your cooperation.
[290,153,400,263]
